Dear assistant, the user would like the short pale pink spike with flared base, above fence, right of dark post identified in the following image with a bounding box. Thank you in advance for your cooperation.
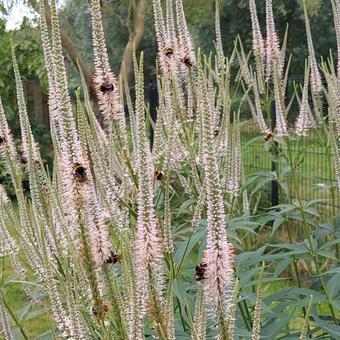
[295,62,315,136]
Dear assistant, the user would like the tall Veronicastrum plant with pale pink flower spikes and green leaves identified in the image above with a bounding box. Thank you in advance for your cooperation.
[0,0,340,339]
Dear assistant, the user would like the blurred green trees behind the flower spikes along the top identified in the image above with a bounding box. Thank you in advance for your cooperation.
[0,0,335,190]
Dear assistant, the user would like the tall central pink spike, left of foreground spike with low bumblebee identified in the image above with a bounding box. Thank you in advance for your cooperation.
[134,51,163,313]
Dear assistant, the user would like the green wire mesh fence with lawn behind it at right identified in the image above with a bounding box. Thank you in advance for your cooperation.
[241,121,340,214]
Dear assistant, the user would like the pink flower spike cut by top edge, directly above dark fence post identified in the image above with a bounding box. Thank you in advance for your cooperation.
[266,0,283,79]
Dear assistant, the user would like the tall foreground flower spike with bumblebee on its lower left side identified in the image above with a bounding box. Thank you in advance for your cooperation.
[198,56,234,332]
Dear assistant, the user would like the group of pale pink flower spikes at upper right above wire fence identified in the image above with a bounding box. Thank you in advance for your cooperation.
[241,0,322,140]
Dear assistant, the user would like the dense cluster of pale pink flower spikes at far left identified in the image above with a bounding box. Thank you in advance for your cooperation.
[0,1,133,339]
